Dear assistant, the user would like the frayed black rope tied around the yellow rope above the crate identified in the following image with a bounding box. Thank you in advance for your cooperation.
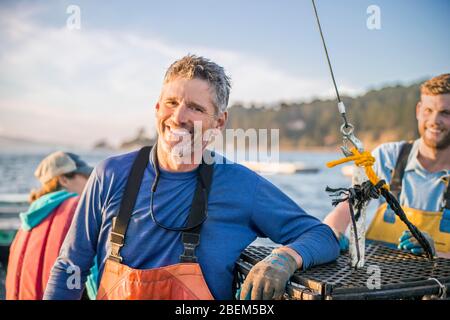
[326,180,433,261]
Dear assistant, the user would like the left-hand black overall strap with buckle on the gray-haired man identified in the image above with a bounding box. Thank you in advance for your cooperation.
[109,146,152,262]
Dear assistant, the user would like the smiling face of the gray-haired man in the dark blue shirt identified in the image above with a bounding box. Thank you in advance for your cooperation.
[156,78,227,156]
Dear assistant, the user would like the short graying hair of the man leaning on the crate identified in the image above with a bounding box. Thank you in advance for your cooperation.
[164,54,231,113]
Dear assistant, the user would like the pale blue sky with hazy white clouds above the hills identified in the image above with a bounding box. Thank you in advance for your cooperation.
[0,0,450,147]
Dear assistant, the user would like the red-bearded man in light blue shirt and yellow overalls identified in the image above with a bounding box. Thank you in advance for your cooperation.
[324,73,450,257]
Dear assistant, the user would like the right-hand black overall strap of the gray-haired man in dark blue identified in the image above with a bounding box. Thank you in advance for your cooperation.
[180,152,214,263]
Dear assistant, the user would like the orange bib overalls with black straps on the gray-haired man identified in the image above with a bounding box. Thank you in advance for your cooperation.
[97,147,214,300]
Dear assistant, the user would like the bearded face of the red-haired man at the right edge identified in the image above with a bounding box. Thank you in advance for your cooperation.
[416,94,450,149]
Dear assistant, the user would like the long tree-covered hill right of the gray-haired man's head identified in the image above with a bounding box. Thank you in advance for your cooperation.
[228,84,420,149]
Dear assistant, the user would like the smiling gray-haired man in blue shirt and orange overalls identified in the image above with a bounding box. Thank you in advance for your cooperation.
[45,55,339,299]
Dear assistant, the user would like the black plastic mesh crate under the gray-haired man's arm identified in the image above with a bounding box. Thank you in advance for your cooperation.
[235,243,450,300]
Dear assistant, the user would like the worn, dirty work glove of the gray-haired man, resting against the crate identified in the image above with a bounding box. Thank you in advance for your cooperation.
[238,249,298,300]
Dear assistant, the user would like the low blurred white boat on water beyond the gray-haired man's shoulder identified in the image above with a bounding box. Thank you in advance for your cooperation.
[241,161,319,174]
